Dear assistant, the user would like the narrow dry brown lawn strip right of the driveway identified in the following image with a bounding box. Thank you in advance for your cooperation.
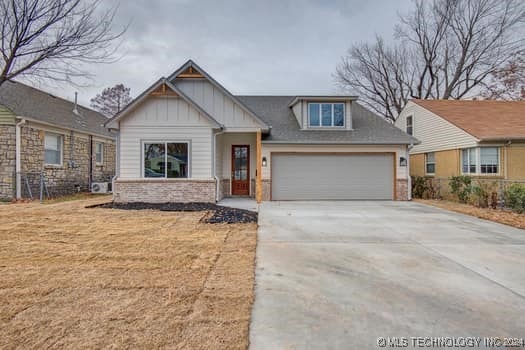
[414,199,525,228]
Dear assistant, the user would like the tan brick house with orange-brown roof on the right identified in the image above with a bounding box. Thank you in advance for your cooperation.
[395,100,525,180]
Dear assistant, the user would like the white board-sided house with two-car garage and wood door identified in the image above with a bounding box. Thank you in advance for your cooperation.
[106,60,417,202]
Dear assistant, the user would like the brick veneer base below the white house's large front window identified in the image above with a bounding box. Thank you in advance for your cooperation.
[113,179,215,203]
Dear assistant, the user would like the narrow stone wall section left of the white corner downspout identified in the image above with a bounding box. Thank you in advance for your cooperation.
[0,125,16,200]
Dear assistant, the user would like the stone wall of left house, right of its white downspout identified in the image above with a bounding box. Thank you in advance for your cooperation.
[21,126,115,197]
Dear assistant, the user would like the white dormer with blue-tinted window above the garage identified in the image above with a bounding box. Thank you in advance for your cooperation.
[288,96,357,130]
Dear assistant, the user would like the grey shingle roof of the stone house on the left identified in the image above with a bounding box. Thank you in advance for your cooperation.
[0,81,115,138]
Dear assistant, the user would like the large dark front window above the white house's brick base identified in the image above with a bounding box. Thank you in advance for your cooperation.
[143,142,189,178]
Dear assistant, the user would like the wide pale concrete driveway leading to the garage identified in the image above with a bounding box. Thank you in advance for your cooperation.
[250,202,525,349]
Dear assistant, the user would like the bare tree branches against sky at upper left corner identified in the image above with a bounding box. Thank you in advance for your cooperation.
[0,0,125,85]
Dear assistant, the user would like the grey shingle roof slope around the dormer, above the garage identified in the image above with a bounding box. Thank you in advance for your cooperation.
[237,96,419,145]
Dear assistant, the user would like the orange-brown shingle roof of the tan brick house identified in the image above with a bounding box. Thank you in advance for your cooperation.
[411,100,525,141]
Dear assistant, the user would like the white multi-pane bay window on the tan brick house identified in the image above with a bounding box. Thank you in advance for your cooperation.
[461,147,499,174]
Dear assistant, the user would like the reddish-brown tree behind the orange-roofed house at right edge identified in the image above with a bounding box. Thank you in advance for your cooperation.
[480,51,525,101]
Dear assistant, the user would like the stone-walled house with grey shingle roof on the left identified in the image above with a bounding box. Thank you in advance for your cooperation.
[0,82,115,199]
